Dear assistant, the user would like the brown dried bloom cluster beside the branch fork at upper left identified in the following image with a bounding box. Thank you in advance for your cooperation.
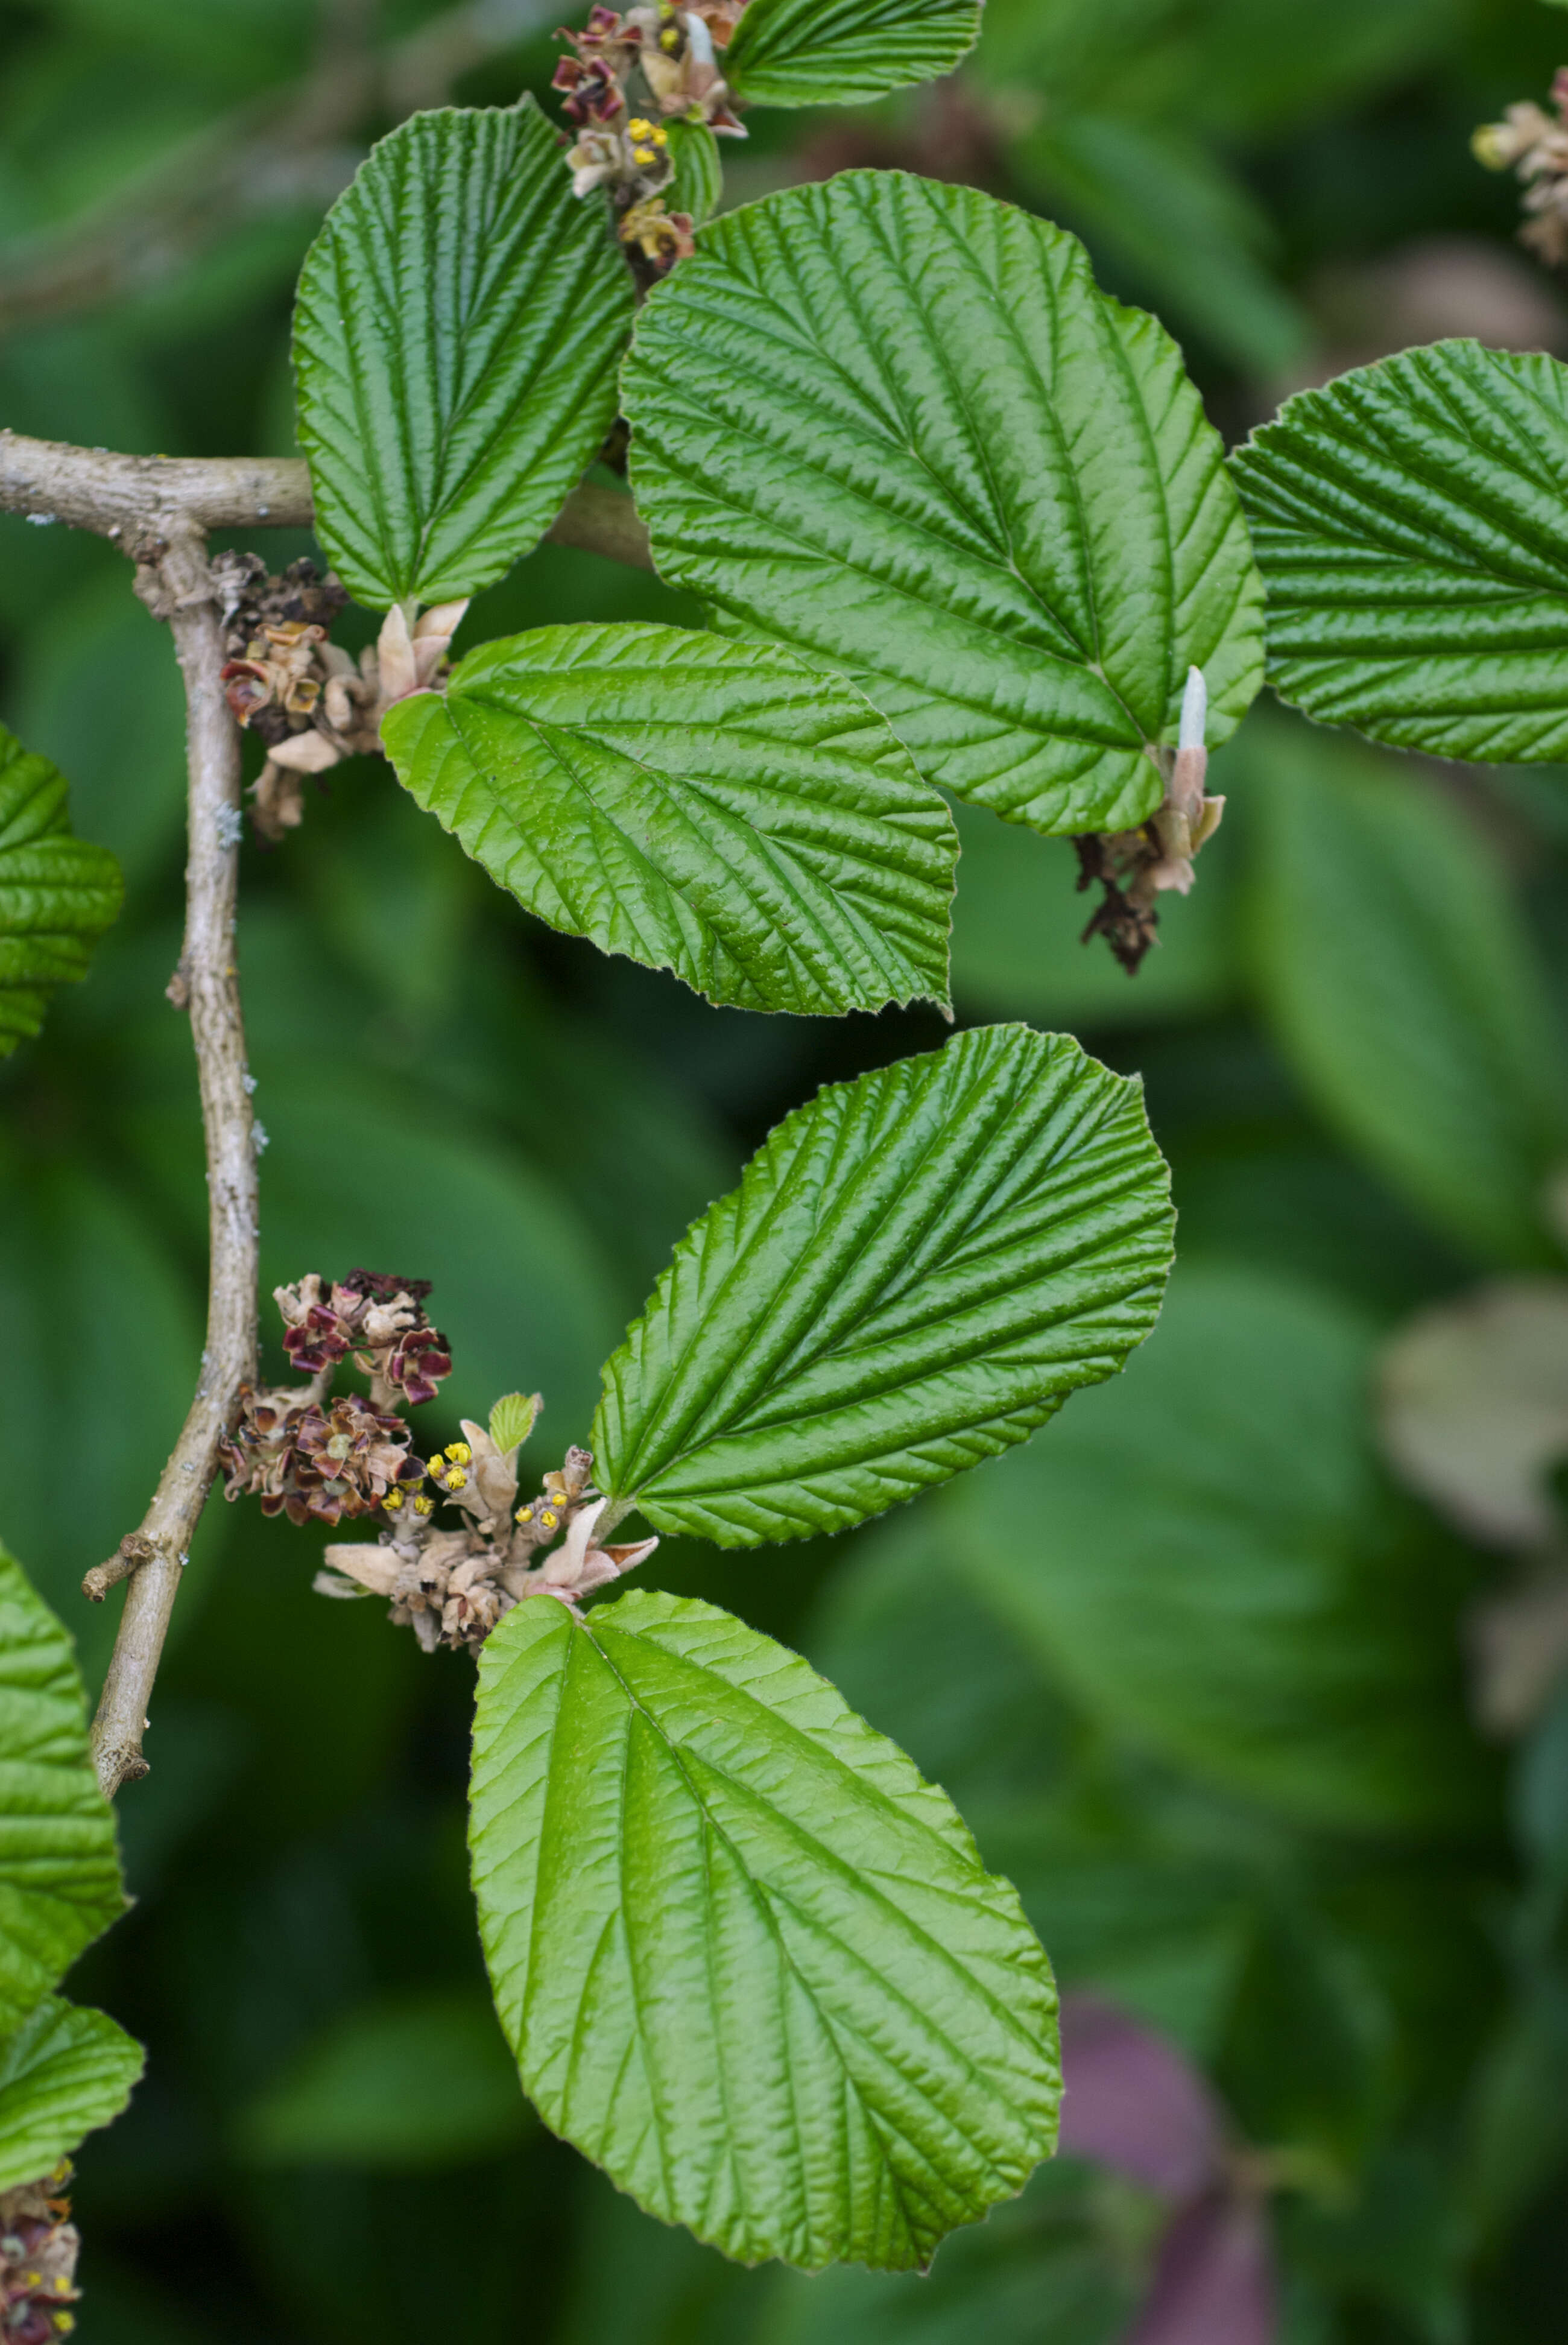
[211,554,469,840]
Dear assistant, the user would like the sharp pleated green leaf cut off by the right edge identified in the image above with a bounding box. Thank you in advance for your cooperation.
[1233,343,1568,762]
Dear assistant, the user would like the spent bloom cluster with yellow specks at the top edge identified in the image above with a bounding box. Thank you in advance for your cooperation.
[555,0,745,279]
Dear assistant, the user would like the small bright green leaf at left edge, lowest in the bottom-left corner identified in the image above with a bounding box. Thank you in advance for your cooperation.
[0,1996,143,2190]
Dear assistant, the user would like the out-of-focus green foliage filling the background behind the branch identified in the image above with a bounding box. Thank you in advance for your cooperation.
[0,0,1568,2345]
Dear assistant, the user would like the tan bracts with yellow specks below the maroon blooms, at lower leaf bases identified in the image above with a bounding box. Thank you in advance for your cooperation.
[317,1425,659,1653]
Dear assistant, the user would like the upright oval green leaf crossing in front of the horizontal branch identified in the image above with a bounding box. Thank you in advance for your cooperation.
[293,98,633,610]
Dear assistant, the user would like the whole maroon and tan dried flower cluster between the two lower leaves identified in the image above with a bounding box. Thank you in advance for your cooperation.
[223,1271,659,1651]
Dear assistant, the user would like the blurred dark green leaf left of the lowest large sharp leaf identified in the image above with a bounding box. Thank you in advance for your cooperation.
[241,1989,532,2174]
